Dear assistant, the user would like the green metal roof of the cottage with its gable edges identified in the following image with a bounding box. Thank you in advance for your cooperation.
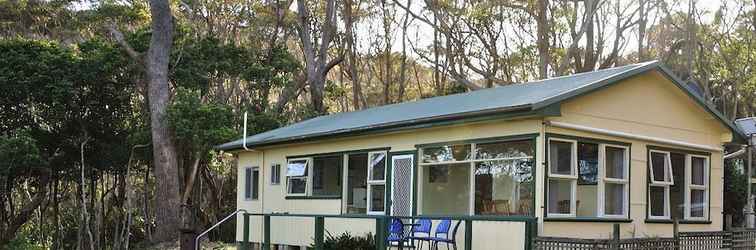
[216,61,743,150]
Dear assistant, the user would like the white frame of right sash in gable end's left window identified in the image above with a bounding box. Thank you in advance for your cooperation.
[596,143,630,219]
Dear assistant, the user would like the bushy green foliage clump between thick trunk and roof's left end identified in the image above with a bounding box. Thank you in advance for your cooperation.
[168,88,237,150]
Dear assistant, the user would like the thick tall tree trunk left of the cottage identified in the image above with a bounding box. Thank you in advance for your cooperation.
[147,0,181,242]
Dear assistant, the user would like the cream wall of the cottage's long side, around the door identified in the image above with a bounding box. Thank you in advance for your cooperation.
[237,119,543,249]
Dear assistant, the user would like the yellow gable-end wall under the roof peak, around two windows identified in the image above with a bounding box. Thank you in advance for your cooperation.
[541,72,729,238]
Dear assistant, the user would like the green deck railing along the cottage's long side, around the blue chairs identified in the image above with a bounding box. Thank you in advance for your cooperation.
[240,213,537,250]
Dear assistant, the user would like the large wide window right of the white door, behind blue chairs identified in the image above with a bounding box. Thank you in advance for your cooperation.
[420,139,535,215]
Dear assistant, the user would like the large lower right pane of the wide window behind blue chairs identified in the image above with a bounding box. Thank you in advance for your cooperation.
[475,159,533,215]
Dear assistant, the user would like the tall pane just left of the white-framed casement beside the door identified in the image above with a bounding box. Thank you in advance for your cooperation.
[346,154,367,214]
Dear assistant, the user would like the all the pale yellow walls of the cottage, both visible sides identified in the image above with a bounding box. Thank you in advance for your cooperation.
[237,72,729,246]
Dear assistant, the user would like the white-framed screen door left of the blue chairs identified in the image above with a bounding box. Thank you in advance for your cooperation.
[391,154,415,216]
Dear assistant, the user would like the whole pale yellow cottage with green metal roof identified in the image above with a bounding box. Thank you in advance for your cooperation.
[218,62,744,250]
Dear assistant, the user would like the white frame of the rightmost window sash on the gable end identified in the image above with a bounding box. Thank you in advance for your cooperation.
[685,154,709,221]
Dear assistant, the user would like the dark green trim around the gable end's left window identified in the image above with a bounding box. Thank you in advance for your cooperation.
[543,133,632,222]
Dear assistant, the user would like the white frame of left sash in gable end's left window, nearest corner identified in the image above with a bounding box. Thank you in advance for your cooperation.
[546,138,578,218]
